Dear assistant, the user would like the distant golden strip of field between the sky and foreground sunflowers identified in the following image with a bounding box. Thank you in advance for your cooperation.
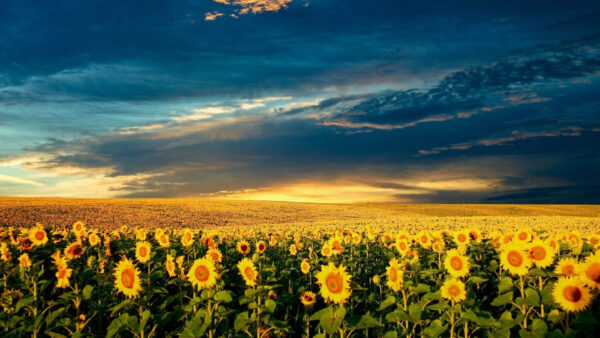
[0,198,600,233]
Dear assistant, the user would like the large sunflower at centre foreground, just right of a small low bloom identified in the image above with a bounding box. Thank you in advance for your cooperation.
[316,262,352,304]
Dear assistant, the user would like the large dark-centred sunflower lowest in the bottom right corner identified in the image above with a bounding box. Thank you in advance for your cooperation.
[552,277,592,312]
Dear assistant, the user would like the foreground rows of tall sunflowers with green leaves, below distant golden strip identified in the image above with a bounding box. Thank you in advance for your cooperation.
[0,222,600,338]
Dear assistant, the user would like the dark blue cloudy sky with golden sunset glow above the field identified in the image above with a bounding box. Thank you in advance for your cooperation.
[0,0,600,204]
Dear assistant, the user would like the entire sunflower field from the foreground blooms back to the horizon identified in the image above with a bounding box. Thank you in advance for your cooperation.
[0,198,600,338]
